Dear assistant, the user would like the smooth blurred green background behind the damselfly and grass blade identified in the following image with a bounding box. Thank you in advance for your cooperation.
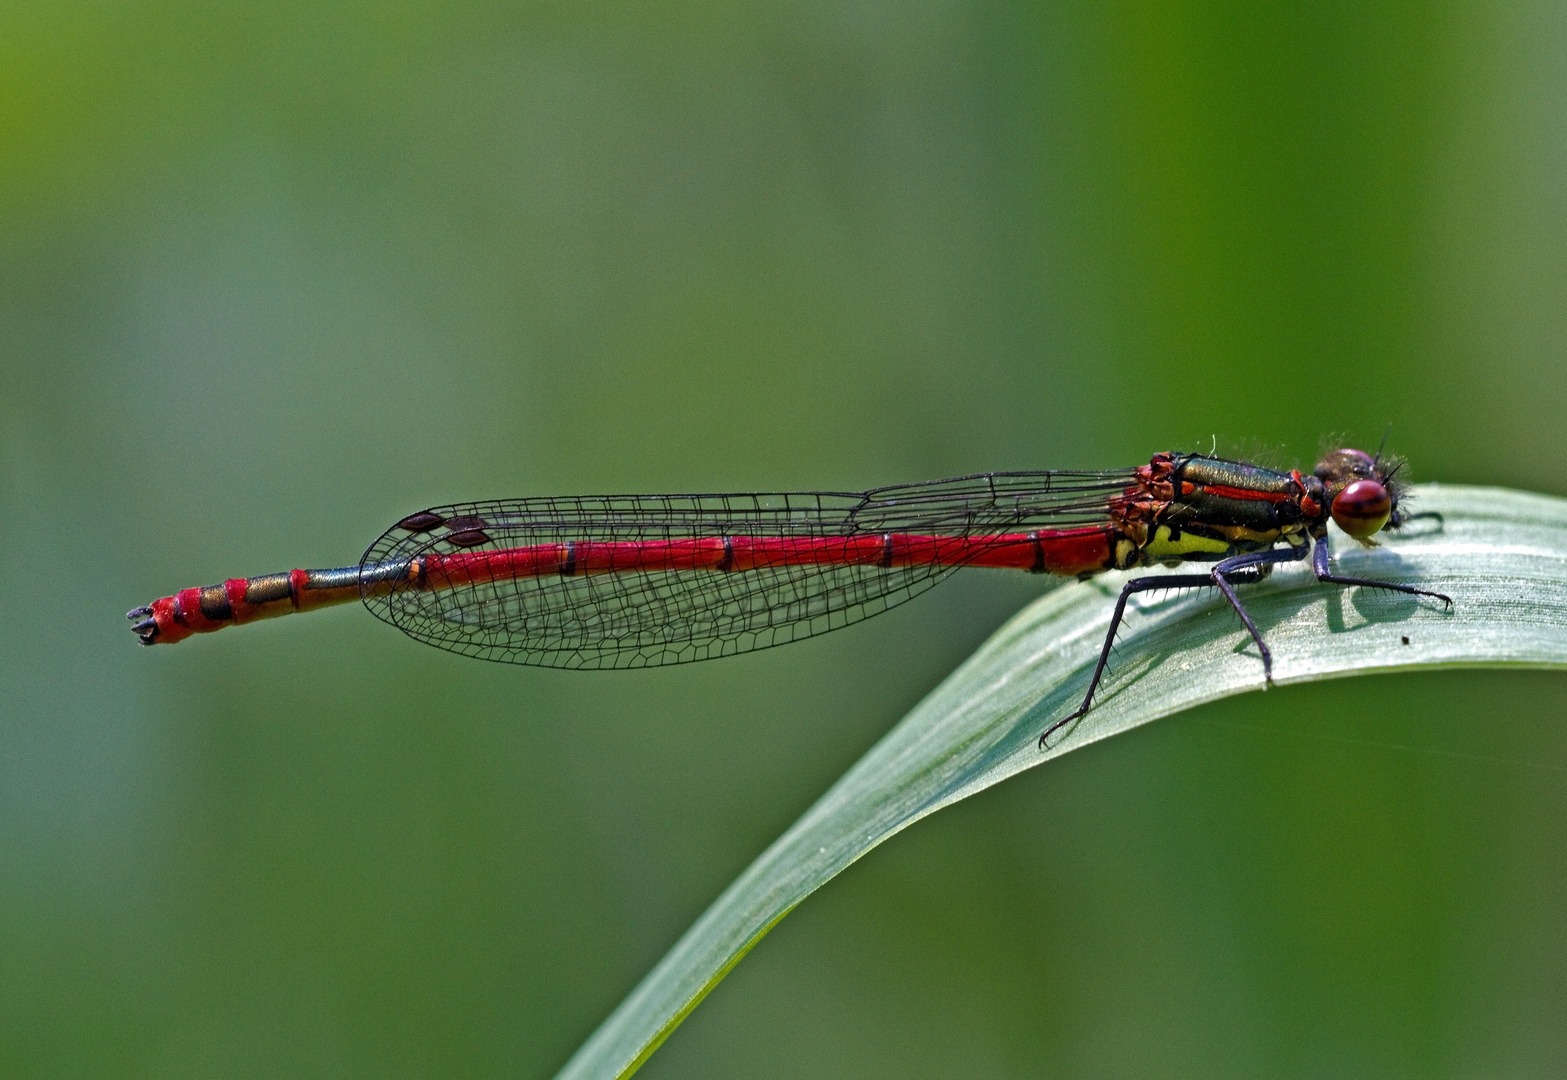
[0,0,1567,1077]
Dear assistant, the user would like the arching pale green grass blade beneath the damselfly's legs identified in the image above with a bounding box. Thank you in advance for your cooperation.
[559,484,1567,1080]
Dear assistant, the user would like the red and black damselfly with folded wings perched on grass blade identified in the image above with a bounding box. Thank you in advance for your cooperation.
[130,450,1453,745]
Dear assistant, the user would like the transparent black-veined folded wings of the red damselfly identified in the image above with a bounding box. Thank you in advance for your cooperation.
[360,469,1131,668]
